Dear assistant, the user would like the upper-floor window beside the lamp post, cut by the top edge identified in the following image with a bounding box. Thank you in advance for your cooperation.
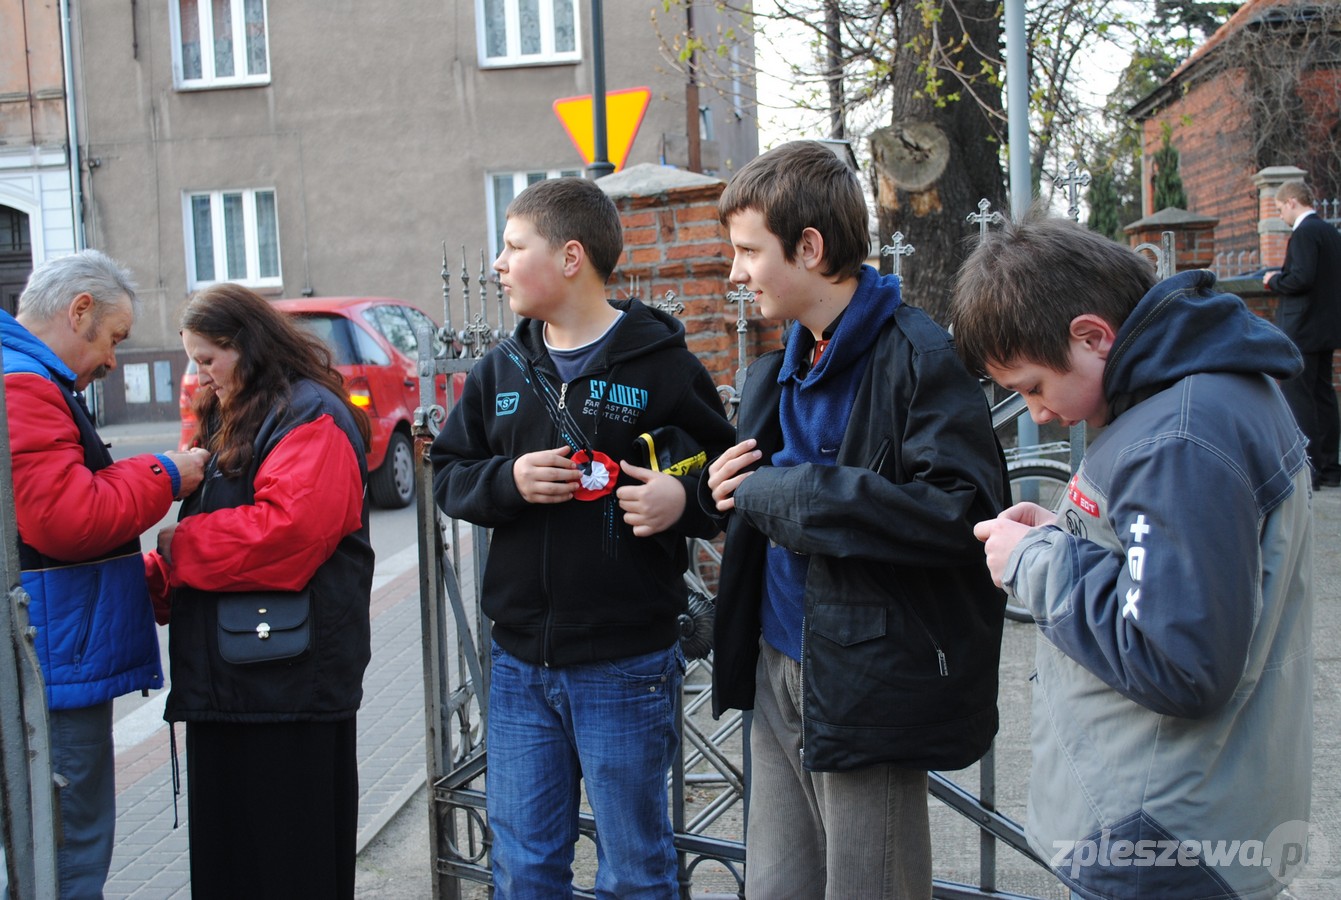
[475,0,582,66]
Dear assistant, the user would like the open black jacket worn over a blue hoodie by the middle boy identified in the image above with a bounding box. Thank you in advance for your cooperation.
[700,306,1007,771]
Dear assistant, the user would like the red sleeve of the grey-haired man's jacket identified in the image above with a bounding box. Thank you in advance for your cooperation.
[4,373,173,562]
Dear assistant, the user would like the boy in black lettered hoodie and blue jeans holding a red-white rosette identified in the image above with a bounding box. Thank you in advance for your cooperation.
[430,178,734,899]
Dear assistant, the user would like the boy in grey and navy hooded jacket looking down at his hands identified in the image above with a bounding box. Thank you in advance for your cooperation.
[952,216,1313,899]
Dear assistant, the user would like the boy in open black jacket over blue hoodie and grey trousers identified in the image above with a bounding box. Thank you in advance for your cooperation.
[703,142,1006,899]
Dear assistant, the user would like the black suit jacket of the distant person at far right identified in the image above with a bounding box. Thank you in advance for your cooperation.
[1270,213,1341,353]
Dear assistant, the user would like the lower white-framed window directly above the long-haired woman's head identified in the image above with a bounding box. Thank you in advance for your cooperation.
[182,190,280,290]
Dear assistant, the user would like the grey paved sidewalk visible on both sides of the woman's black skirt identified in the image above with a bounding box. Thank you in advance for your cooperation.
[106,547,428,900]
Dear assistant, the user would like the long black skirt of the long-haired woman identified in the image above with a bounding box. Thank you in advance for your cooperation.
[186,719,358,900]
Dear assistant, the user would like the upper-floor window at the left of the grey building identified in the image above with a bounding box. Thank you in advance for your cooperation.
[168,0,270,89]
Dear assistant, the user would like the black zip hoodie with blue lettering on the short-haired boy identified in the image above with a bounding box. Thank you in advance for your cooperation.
[430,300,735,665]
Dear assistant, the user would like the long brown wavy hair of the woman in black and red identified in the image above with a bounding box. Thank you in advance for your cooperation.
[181,283,371,476]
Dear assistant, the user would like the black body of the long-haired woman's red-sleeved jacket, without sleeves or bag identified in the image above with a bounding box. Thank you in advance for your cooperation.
[164,381,373,722]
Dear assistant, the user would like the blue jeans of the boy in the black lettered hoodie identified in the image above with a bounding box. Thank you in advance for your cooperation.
[487,644,683,900]
